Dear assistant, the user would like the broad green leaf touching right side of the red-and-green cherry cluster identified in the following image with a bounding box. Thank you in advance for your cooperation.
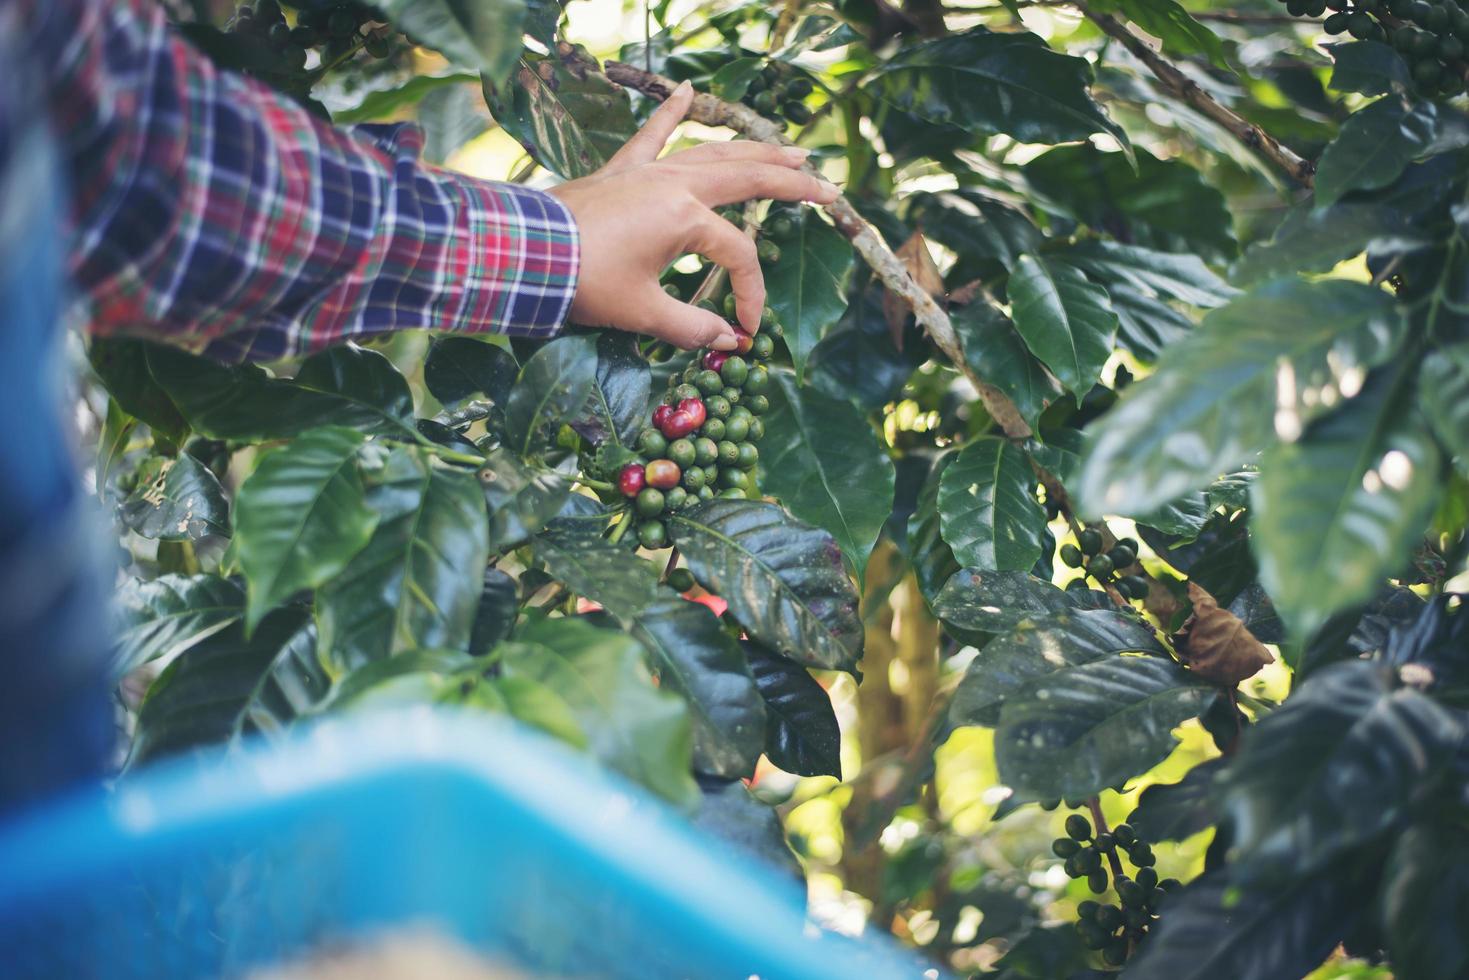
[759,369,896,579]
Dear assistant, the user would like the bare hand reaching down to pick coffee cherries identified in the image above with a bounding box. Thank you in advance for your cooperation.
[551,82,837,350]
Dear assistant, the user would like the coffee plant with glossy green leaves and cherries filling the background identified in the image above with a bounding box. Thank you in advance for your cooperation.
[94,0,1469,980]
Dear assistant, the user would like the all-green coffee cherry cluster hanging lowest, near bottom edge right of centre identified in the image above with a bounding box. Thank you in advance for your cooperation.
[1050,814,1183,967]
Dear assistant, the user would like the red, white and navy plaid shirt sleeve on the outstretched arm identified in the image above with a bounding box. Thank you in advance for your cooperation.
[0,0,579,360]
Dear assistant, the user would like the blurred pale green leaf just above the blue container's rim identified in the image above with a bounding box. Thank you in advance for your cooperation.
[501,619,698,805]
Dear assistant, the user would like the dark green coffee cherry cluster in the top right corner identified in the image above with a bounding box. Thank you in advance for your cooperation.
[1284,0,1469,97]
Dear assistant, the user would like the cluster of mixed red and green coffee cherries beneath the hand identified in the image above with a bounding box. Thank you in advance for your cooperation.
[617,328,776,548]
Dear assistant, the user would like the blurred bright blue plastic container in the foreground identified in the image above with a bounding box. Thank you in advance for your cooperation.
[0,710,937,980]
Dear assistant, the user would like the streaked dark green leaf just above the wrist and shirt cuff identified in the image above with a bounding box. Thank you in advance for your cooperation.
[485,54,638,179]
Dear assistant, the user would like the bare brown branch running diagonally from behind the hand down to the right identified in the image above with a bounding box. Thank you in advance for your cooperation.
[604,62,1031,439]
